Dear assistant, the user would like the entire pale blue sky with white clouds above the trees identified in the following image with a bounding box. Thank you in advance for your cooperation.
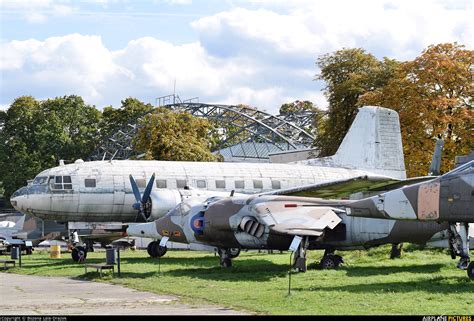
[0,0,474,112]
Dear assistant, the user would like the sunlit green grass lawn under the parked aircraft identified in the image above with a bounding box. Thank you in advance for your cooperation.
[1,246,474,315]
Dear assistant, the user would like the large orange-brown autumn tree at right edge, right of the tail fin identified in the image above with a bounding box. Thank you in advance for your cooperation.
[360,43,474,176]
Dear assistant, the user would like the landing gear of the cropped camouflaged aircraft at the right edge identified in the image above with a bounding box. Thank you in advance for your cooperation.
[448,223,474,279]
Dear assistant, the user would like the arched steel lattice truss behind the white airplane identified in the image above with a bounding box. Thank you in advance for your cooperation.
[89,102,314,160]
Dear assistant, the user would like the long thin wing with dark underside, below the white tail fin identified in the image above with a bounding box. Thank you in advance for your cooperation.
[258,175,435,199]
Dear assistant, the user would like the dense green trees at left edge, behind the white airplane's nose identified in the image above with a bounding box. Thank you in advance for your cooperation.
[0,96,100,198]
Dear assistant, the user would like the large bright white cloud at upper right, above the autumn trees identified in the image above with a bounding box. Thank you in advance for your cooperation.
[193,0,473,59]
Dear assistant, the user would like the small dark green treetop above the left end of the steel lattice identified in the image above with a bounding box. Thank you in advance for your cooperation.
[100,97,153,139]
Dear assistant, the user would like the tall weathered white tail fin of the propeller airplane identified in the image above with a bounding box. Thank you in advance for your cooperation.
[302,106,406,179]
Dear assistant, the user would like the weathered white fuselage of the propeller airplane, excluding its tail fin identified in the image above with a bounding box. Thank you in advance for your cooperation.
[11,160,371,222]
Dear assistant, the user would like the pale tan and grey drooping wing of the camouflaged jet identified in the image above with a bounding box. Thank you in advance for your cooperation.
[256,203,341,236]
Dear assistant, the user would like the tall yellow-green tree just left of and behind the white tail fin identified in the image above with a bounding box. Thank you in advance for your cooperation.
[314,48,399,156]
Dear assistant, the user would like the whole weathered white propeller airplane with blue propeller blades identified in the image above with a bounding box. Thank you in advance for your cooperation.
[11,106,407,262]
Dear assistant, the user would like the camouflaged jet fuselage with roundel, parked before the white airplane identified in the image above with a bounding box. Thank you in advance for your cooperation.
[140,196,448,250]
